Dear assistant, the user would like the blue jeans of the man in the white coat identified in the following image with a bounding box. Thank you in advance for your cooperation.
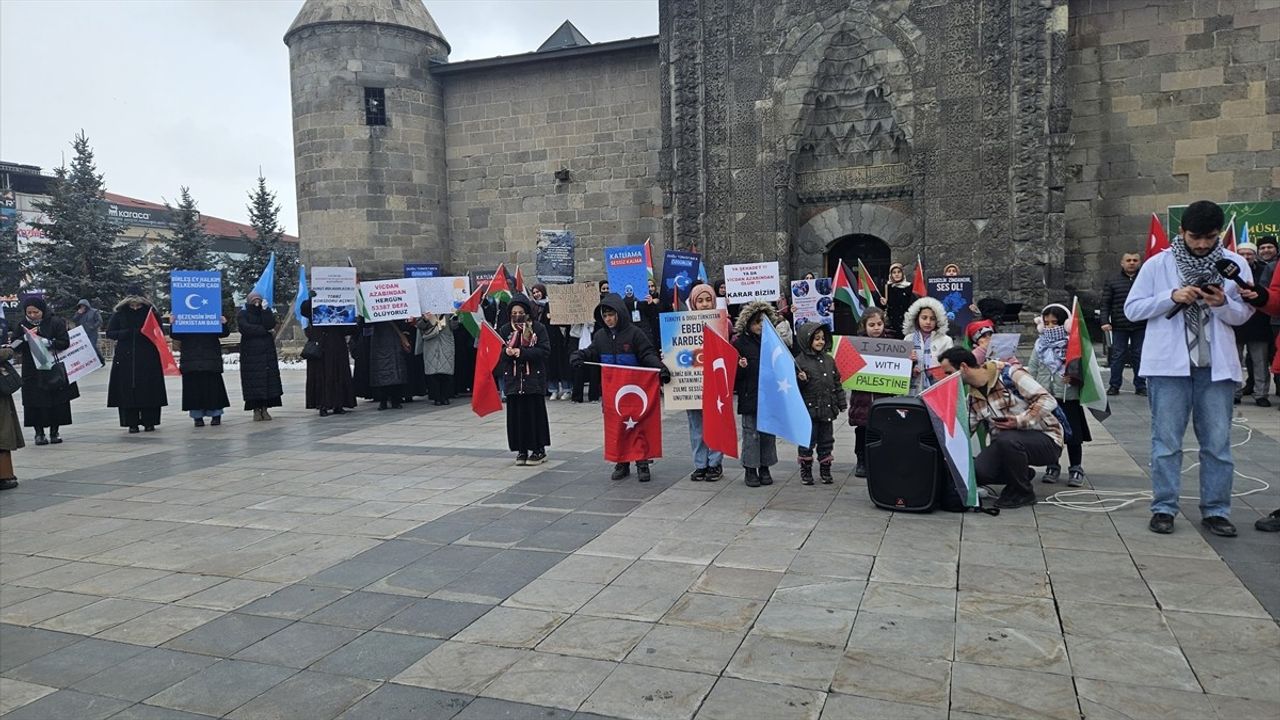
[1147,368,1235,518]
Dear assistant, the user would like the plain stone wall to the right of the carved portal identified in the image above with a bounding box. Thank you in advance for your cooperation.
[1065,0,1280,293]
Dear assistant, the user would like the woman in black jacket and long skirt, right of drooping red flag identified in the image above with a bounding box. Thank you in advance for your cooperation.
[494,295,552,465]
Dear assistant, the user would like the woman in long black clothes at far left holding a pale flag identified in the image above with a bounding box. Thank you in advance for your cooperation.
[19,297,79,445]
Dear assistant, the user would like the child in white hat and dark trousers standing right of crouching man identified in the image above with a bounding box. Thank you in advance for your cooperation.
[1027,304,1093,488]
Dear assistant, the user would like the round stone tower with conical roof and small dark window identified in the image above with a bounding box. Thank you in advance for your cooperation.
[284,0,449,279]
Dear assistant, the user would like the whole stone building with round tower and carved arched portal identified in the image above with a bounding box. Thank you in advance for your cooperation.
[284,0,1280,307]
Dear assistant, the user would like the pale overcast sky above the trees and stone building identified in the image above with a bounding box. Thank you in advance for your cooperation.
[0,0,658,233]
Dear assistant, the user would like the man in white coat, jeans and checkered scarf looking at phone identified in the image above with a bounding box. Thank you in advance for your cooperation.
[1124,200,1253,537]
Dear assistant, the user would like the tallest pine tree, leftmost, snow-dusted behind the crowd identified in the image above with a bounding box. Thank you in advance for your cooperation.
[29,131,142,313]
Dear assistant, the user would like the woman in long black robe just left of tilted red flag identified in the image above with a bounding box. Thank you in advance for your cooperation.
[106,292,169,433]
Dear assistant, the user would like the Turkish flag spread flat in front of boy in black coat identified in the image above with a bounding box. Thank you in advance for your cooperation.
[600,365,662,462]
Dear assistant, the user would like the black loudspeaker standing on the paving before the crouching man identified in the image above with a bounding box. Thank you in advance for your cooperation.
[867,397,948,512]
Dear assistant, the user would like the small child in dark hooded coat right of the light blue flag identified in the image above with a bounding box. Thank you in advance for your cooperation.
[793,322,844,486]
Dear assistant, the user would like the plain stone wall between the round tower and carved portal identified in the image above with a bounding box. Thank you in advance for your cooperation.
[440,44,662,281]
